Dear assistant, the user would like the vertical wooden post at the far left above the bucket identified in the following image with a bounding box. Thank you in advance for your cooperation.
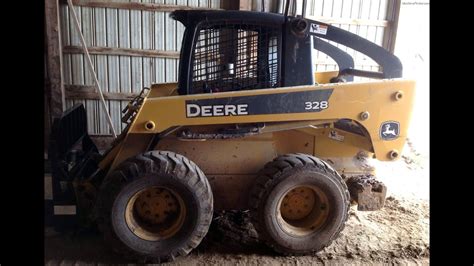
[45,0,65,117]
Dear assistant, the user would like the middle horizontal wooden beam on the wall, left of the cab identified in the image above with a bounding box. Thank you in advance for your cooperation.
[63,46,179,59]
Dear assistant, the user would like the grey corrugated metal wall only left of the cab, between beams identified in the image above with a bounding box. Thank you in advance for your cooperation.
[60,0,220,135]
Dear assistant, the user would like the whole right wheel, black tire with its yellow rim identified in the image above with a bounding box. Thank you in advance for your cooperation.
[250,154,350,255]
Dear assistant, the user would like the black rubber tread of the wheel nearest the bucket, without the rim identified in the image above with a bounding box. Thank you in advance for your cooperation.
[97,151,213,263]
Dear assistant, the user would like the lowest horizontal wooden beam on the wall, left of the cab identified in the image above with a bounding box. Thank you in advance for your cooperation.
[64,85,138,101]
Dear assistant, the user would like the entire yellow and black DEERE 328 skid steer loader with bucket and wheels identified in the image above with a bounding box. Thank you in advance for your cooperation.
[49,5,415,261]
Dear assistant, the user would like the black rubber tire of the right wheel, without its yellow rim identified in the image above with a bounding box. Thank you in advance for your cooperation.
[249,153,350,255]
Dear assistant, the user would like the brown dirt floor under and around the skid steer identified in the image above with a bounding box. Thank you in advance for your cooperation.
[45,142,430,265]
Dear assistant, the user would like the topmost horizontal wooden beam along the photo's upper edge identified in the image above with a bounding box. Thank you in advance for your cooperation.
[61,0,220,12]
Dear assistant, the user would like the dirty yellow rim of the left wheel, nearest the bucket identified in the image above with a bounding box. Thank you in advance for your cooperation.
[125,186,186,241]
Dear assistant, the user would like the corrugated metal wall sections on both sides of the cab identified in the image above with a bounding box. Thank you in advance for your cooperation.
[60,0,393,135]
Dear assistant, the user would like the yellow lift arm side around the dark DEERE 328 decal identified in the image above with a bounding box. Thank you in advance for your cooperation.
[130,79,415,160]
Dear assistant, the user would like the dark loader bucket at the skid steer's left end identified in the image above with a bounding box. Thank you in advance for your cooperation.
[48,104,100,231]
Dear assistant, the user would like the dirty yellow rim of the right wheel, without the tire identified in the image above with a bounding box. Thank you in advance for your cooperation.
[277,185,330,236]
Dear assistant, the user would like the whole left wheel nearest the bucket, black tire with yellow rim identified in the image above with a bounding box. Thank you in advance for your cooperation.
[98,151,213,262]
